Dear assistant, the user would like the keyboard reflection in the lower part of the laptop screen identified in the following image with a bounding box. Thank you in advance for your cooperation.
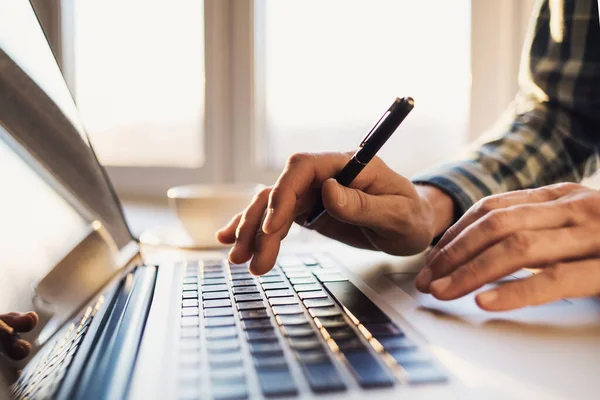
[11,296,104,399]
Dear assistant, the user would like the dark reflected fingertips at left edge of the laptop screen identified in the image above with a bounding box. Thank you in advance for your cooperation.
[0,312,38,360]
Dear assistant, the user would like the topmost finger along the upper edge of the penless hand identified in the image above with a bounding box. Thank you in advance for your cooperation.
[426,184,578,261]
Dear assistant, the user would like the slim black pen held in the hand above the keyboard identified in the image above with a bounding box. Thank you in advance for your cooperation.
[304,97,415,226]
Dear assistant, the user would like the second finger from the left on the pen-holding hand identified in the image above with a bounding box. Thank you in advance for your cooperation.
[229,188,271,264]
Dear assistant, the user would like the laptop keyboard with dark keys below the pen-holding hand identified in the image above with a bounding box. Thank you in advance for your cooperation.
[179,255,447,400]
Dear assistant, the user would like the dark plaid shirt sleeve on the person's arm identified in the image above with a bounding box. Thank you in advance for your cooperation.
[414,0,600,217]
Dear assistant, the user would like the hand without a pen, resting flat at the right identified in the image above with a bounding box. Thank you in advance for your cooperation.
[416,183,600,311]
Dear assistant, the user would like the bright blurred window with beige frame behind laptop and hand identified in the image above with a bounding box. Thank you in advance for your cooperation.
[32,0,534,212]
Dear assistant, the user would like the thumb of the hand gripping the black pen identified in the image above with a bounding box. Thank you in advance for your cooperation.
[322,179,409,233]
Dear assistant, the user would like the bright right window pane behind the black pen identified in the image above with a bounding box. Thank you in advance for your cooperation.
[255,0,471,174]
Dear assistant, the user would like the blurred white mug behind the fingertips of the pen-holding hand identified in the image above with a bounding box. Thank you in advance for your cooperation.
[167,183,263,247]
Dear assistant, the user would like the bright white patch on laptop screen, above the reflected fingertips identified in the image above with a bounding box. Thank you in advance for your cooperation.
[0,125,90,311]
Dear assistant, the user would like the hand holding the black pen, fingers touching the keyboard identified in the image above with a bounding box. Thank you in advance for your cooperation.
[217,153,454,275]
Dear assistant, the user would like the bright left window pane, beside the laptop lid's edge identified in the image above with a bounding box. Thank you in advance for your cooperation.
[64,0,204,168]
